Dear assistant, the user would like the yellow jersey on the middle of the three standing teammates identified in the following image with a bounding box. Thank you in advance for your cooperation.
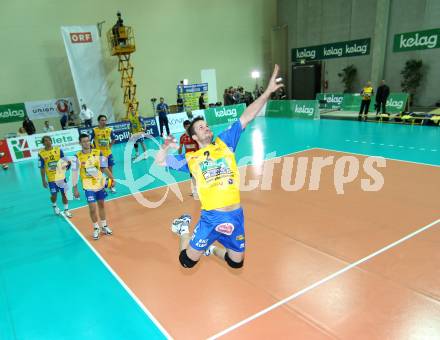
[74,149,107,191]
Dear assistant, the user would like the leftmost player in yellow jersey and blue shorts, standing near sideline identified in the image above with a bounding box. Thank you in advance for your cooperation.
[38,136,72,218]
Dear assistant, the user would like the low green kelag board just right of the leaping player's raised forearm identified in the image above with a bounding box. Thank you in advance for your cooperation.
[266,100,319,119]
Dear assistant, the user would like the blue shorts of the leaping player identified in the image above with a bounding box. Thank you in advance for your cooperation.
[190,208,245,253]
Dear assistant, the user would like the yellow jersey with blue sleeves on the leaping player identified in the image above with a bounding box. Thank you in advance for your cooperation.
[166,121,243,210]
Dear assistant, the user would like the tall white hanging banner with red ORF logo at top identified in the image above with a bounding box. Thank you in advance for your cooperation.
[61,25,115,124]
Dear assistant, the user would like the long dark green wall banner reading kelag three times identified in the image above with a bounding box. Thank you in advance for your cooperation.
[292,38,371,62]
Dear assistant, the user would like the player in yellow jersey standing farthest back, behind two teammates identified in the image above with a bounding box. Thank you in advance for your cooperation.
[90,115,116,193]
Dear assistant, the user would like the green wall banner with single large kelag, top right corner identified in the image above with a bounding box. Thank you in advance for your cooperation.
[393,28,440,52]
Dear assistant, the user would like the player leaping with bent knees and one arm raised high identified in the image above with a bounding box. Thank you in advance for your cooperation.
[156,65,283,268]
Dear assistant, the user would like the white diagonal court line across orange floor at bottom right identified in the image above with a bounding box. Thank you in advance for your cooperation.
[208,219,440,340]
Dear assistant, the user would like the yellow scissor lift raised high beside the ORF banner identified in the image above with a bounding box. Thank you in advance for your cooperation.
[107,26,139,115]
